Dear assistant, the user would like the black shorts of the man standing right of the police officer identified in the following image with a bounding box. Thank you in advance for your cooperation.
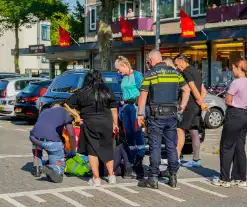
[177,105,201,130]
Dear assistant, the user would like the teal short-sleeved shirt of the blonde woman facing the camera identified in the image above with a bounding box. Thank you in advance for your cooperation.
[121,71,143,100]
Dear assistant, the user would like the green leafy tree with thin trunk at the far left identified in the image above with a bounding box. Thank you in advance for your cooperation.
[0,0,68,73]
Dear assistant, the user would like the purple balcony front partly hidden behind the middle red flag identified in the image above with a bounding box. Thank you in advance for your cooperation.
[111,17,153,34]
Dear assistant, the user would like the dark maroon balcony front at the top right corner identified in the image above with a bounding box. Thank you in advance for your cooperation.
[207,3,247,23]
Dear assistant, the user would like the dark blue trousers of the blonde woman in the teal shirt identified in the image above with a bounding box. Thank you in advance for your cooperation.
[122,104,145,163]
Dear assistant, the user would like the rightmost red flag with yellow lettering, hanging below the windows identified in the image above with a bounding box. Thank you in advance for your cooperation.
[180,8,196,38]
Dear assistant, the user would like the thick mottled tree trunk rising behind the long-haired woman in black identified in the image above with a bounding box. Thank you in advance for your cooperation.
[98,0,119,70]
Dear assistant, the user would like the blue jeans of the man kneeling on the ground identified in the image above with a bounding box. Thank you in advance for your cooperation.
[30,136,65,174]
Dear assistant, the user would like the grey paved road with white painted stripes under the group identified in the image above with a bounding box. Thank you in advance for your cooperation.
[0,117,247,207]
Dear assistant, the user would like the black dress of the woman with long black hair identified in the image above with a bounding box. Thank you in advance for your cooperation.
[67,89,117,162]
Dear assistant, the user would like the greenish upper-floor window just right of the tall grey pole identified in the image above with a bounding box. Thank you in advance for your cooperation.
[160,0,185,19]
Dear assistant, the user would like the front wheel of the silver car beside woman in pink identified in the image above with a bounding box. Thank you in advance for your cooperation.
[204,108,224,129]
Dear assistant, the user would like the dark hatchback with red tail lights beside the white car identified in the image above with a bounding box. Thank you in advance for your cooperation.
[14,80,52,123]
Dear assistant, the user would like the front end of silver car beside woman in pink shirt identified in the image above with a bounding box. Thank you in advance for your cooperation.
[202,94,226,129]
